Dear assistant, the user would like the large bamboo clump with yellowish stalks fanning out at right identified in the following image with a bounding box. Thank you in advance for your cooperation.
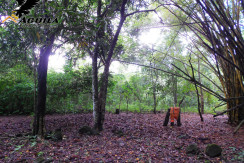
[171,0,244,123]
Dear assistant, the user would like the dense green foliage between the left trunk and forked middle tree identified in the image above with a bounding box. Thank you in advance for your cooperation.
[47,66,92,113]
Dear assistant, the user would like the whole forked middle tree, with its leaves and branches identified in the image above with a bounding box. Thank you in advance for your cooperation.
[80,0,160,131]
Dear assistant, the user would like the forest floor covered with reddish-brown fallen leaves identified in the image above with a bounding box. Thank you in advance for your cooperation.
[0,113,244,163]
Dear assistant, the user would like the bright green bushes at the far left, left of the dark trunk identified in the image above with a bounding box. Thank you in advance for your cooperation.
[0,65,34,114]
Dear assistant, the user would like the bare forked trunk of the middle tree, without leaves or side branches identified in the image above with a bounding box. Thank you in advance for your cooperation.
[92,0,127,131]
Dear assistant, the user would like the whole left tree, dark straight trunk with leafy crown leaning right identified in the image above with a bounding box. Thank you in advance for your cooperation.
[33,0,90,136]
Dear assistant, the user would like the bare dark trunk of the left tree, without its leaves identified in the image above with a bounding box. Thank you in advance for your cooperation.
[33,34,55,136]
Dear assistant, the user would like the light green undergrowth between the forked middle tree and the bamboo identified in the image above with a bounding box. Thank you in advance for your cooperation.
[106,69,220,113]
